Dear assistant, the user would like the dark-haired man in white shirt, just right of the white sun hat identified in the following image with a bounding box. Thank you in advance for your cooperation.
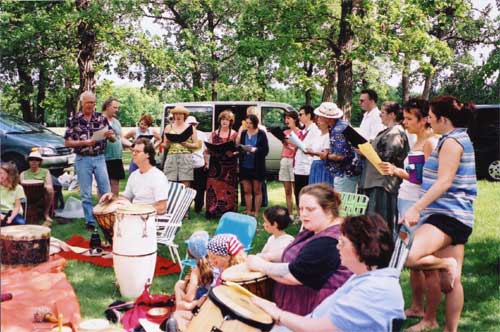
[359,89,385,141]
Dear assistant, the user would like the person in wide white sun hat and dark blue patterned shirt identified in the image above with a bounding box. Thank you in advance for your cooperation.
[314,102,361,193]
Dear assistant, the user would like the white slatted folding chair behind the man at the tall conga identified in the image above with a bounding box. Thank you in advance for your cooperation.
[156,185,196,264]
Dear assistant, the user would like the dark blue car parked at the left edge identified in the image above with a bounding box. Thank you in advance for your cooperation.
[0,114,75,176]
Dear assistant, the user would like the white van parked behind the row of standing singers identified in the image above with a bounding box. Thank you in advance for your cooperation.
[161,101,295,175]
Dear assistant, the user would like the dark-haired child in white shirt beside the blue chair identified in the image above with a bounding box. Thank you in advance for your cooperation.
[258,206,294,262]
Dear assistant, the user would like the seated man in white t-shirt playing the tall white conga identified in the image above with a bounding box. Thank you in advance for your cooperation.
[99,138,168,215]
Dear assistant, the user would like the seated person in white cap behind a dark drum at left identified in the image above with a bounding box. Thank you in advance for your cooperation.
[20,151,54,227]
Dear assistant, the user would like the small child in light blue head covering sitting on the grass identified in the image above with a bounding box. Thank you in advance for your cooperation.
[174,231,214,310]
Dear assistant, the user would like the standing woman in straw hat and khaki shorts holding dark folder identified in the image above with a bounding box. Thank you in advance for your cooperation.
[163,106,201,187]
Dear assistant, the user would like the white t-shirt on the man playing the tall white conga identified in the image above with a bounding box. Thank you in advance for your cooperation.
[123,167,168,204]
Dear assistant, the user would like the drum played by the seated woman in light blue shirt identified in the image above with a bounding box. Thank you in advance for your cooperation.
[186,285,273,332]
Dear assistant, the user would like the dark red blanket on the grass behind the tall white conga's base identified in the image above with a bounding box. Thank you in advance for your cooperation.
[58,235,181,276]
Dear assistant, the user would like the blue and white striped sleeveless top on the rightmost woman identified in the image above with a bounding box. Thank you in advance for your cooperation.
[421,128,477,228]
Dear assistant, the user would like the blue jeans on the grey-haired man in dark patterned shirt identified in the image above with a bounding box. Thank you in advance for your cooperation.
[75,154,111,225]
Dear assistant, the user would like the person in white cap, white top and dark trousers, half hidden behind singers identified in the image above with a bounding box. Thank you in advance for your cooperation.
[186,115,208,213]
